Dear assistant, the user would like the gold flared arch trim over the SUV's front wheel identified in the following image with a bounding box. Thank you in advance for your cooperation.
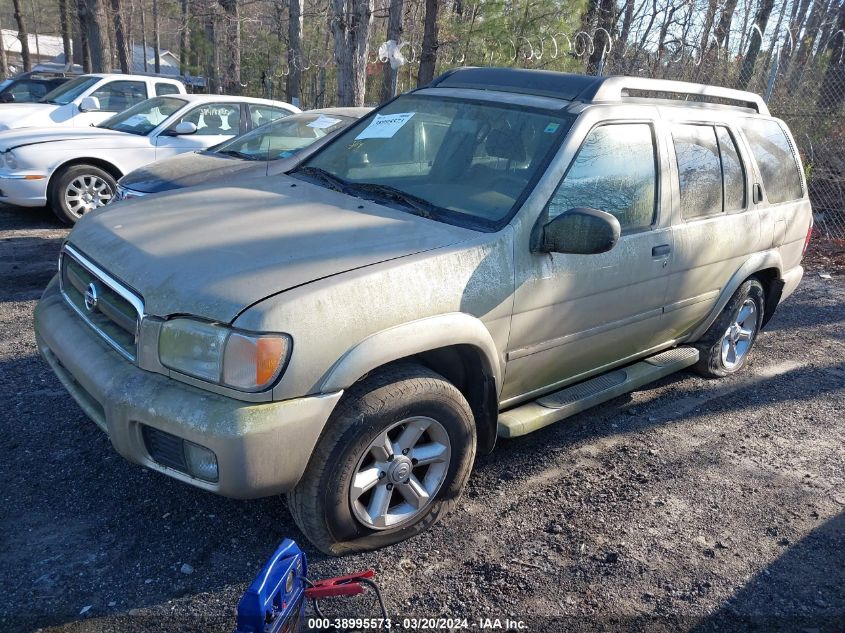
[319,312,504,393]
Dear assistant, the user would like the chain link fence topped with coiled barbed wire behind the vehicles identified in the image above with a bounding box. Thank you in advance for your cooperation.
[260,26,845,239]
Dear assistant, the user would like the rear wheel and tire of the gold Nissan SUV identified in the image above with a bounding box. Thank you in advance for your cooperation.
[693,277,765,378]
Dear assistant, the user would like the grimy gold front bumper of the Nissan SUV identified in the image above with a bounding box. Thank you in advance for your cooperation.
[35,279,342,499]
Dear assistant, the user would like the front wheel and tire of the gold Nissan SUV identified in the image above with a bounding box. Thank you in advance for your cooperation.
[288,363,476,556]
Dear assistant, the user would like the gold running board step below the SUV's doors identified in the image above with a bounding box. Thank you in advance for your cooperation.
[498,347,698,437]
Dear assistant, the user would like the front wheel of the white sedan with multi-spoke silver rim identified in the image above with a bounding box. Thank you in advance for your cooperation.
[50,165,117,225]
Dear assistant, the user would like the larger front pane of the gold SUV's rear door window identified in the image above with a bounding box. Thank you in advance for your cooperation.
[672,125,722,220]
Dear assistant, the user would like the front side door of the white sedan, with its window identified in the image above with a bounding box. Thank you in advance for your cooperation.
[156,103,241,160]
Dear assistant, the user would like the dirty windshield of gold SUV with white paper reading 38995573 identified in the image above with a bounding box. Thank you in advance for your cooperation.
[292,94,570,229]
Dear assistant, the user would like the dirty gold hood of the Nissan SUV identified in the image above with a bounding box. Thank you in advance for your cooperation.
[68,176,477,323]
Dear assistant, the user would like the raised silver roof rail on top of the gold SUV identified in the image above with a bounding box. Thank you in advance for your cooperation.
[578,76,769,116]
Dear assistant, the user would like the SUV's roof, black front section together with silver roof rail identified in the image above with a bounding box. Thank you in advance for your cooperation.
[427,67,769,116]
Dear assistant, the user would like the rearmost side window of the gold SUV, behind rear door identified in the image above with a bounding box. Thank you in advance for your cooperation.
[740,119,804,204]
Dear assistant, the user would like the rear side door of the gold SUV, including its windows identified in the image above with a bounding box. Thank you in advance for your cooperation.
[658,120,770,342]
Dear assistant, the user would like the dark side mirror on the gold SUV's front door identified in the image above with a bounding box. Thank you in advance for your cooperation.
[539,207,622,255]
